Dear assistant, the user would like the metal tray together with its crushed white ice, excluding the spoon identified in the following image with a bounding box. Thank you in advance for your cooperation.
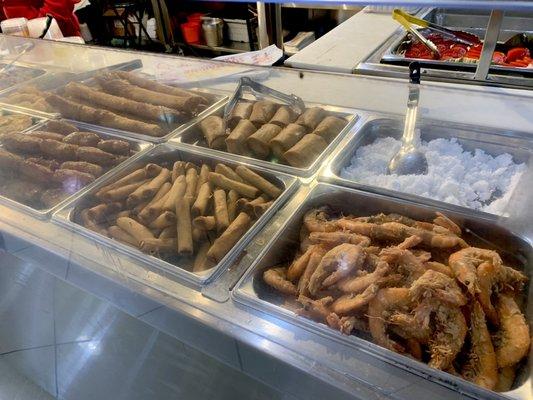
[320,116,533,216]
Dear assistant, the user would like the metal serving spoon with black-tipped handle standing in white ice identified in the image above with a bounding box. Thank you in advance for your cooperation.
[388,61,428,175]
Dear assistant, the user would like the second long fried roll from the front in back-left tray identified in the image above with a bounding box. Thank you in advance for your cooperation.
[65,82,181,122]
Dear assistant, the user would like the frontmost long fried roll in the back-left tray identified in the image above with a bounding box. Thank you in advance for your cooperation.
[46,94,165,137]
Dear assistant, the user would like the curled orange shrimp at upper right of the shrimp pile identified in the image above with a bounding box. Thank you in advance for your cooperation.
[448,247,502,296]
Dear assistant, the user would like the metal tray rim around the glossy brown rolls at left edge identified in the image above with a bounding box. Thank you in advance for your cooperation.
[0,120,152,220]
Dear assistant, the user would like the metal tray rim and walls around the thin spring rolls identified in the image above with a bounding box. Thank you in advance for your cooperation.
[52,143,298,286]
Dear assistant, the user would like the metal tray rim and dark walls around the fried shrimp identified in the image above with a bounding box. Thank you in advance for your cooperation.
[232,183,533,399]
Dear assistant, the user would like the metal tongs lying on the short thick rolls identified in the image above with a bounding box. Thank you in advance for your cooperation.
[224,76,305,123]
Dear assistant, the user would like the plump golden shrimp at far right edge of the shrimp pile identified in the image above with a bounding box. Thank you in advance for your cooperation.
[494,294,530,368]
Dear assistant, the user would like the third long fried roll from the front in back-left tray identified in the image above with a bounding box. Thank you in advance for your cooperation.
[102,79,201,114]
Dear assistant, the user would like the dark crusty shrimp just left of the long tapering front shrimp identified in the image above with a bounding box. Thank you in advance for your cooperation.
[428,304,468,369]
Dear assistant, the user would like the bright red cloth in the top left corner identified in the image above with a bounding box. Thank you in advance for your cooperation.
[0,0,81,36]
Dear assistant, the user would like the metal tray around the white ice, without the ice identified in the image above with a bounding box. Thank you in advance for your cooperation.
[319,114,533,219]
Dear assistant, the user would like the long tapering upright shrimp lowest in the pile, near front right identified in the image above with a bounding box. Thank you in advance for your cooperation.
[462,301,498,390]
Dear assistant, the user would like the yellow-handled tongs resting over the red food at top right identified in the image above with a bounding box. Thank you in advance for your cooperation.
[392,9,478,57]
